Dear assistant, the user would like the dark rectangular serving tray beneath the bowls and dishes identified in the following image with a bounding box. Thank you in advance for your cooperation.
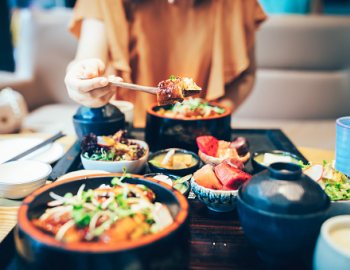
[0,129,308,270]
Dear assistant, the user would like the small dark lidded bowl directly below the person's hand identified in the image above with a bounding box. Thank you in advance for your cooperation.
[73,104,125,140]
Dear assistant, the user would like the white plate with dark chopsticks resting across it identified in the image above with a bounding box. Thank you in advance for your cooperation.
[0,138,64,164]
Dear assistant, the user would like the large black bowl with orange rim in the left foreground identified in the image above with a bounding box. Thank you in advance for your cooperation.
[15,174,189,270]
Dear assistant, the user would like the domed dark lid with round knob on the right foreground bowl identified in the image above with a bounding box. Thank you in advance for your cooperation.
[239,162,330,215]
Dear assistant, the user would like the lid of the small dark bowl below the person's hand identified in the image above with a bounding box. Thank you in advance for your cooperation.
[73,104,125,123]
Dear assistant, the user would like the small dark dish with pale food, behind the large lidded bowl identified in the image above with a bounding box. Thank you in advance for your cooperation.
[251,150,302,172]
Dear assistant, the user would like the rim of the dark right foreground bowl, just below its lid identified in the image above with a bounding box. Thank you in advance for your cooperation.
[237,187,331,220]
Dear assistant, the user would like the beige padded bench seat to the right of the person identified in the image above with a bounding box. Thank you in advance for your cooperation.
[233,16,350,149]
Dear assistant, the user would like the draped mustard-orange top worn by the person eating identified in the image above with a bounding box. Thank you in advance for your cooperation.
[70,0,266,126]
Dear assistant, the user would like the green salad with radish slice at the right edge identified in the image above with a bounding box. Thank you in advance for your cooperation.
[303,162,350,201]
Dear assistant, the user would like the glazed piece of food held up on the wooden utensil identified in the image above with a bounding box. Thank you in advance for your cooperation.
[157,76,202,105]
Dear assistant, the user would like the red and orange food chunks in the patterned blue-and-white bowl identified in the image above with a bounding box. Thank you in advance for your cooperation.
[193,159,251,190]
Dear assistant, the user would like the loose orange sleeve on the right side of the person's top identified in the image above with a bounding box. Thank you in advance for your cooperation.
[206,0,266,100]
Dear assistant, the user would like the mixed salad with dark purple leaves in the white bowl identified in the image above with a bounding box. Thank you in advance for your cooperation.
[81,130,146,161]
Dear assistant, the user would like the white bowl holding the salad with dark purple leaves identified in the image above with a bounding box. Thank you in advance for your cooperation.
[80,139,149,173]
